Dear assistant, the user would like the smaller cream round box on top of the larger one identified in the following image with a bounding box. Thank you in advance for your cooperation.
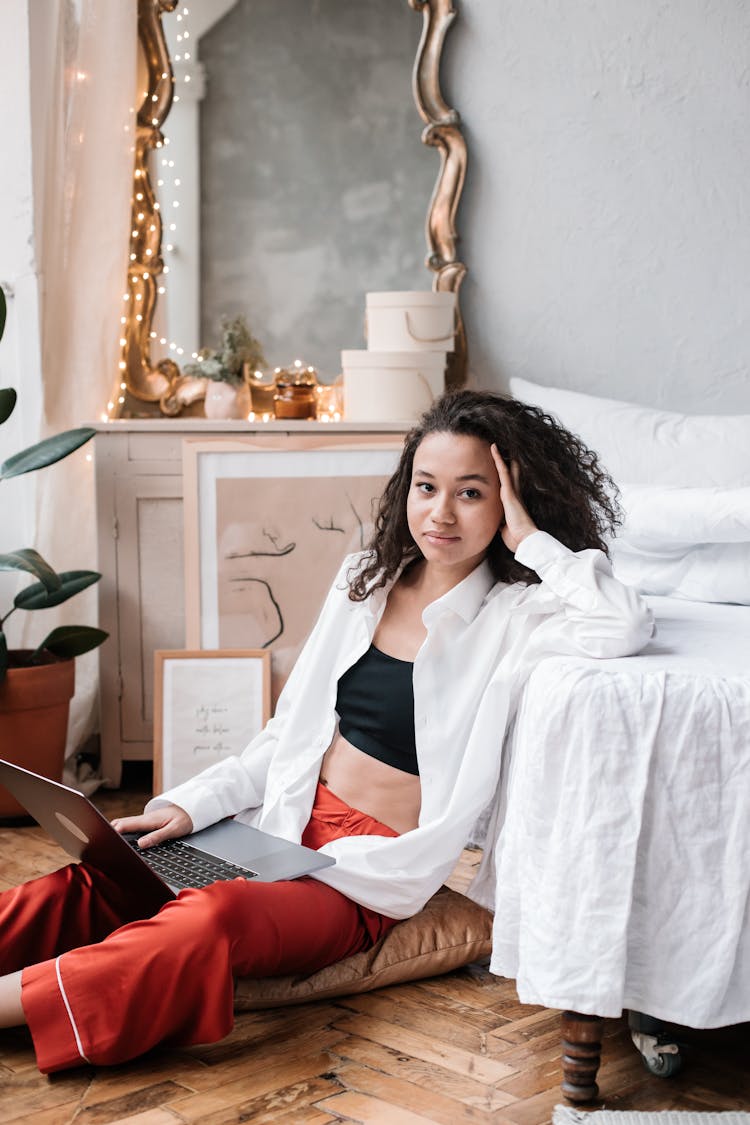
[365,290,455,351]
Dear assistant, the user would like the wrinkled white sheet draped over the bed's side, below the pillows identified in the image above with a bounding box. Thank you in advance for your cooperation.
[490,597,750,1027]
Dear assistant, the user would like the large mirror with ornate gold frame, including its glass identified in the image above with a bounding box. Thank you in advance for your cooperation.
[119,0,466,415]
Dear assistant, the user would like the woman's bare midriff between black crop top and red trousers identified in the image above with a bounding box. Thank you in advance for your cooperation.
[320,730,422,835]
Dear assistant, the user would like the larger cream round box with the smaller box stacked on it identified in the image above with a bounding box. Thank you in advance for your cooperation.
[341,351,445,422]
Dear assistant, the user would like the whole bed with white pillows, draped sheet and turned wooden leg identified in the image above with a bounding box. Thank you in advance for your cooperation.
[488,380,750,1101]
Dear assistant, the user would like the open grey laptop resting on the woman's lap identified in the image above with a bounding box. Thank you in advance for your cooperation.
[0,758,335,910]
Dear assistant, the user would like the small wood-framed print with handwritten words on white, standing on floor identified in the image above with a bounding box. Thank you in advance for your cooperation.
[154,648,271,793]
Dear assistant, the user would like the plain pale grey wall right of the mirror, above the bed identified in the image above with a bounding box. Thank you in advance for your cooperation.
[452,0,750,413]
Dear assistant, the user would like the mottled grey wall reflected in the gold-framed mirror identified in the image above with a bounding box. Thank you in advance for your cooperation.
[200,0,439,379]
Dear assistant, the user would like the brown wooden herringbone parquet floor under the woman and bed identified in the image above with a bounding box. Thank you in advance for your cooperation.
[0,775,750,1125]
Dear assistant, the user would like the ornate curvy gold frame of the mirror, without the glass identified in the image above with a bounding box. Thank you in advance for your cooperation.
[117,0,467,417]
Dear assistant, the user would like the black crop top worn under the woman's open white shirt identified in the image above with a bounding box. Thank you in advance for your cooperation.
[336,645,419,776]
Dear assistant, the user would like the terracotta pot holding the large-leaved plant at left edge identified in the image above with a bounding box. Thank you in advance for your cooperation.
[0,654,75,819]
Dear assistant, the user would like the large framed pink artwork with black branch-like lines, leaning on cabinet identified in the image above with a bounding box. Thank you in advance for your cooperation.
[182,433,403,705]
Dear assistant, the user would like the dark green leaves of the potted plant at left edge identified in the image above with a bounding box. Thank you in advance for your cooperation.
[0,288,108,681]
